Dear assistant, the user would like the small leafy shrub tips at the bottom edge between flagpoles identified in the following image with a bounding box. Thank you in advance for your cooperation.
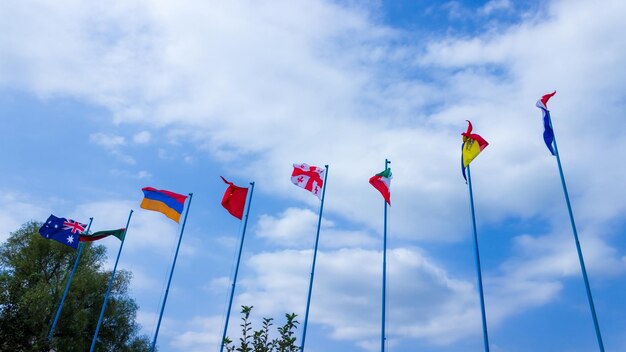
[223,306,300,352]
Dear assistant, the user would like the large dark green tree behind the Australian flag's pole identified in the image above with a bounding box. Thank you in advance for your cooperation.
[0,222,149,352]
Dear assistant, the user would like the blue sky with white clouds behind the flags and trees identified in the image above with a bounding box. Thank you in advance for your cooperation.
[0,0,626,352]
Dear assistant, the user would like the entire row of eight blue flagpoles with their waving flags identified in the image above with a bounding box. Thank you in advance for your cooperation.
[39,92,604,352]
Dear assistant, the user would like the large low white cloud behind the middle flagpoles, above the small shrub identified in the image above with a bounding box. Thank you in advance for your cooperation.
[229,249,528,347]
